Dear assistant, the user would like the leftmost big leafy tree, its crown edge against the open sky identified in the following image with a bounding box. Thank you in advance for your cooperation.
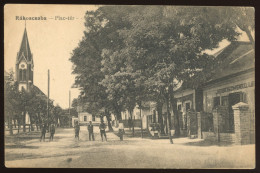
[71,6,137,124]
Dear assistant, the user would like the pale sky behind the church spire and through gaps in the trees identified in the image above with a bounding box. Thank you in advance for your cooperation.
[4,4,252,108]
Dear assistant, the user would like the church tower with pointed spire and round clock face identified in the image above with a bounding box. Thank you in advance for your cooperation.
[15,26,34,91]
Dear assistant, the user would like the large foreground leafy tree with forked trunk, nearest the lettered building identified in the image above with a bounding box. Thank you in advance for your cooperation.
[102,6,247,142]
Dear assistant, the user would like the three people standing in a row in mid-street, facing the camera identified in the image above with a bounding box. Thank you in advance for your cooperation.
[74,121,107,142]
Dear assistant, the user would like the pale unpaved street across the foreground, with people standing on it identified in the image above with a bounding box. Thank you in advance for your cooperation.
[5,127,255,168]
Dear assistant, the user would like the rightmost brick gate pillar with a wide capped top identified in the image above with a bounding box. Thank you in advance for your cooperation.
[232,102,250,145]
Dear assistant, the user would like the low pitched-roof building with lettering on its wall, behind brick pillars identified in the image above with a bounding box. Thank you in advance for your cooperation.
[202,42,255,143]
